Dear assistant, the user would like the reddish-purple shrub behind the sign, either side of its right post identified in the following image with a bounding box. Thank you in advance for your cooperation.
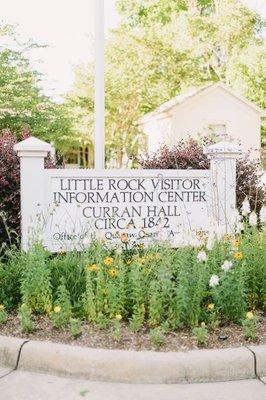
[139,137,266,212]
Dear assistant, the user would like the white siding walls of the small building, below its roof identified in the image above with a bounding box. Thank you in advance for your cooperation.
[143,87,261,157]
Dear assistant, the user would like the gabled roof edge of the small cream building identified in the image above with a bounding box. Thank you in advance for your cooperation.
[139,82,266,124]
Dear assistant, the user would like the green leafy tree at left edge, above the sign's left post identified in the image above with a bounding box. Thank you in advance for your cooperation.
[0,25,72,152]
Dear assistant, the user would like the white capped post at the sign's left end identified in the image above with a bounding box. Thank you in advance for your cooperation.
[14,137,51,251]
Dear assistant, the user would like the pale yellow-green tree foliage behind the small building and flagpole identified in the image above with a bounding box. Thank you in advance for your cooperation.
[67,0,266,167]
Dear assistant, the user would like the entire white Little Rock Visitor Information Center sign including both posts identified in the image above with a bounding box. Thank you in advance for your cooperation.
[15,138,239,251]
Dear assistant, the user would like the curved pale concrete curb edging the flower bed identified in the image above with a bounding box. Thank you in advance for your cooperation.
[0,336,266,383]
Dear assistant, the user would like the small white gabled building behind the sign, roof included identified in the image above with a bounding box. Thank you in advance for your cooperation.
[139,82,266,154]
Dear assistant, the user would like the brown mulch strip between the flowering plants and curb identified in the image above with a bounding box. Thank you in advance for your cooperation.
[0,314,266,351]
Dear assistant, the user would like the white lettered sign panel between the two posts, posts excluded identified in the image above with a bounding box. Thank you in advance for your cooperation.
[45,170,210,249]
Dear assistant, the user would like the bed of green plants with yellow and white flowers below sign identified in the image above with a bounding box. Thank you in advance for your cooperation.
[0,203,266,345]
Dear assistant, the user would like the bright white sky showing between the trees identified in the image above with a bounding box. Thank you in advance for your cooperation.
[0,0,266,100]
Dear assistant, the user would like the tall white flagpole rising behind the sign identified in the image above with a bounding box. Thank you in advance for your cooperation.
[94,0,105,169]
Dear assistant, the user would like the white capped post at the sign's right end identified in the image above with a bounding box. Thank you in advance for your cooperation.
[205,141,241,233]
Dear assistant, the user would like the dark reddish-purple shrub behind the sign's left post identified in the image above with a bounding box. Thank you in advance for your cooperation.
[0,131,59,250]
